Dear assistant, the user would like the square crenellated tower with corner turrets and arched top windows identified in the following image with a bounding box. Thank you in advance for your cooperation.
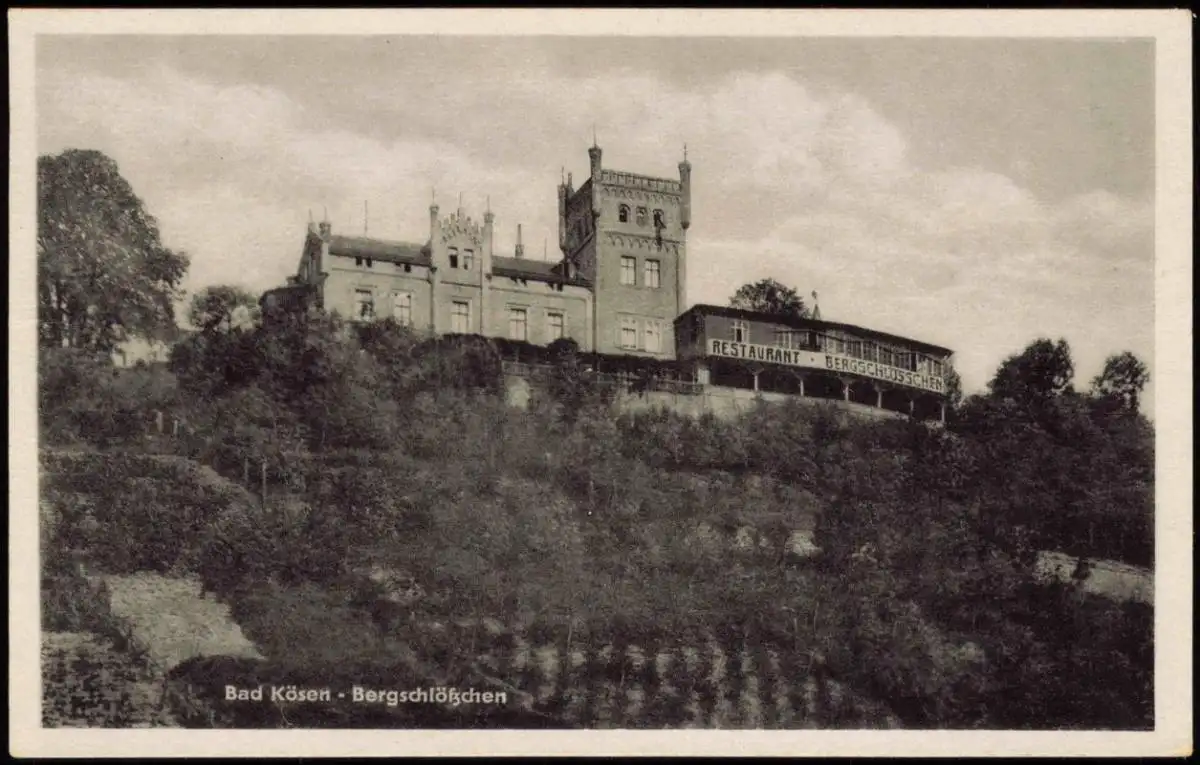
[558,144,691,359]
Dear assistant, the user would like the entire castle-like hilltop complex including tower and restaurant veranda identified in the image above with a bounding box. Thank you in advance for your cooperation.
[263,140,953,418]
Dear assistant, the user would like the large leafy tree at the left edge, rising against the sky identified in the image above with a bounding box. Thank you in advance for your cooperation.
[37,149,188,351]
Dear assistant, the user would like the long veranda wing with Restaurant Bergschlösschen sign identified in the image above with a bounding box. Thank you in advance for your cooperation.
[676,305,953,420]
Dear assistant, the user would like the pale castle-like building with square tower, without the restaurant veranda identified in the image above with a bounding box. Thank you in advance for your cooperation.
[263,146,691,360]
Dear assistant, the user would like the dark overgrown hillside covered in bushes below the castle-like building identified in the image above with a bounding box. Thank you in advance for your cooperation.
[42,318,1153,729]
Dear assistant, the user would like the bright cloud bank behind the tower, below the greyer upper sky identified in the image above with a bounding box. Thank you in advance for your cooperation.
[38,59,1153,410]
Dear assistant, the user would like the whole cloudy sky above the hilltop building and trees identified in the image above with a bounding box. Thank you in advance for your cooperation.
[35,35,1156,405]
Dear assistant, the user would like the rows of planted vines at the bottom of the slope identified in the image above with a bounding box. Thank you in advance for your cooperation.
[458,631,900,729]
